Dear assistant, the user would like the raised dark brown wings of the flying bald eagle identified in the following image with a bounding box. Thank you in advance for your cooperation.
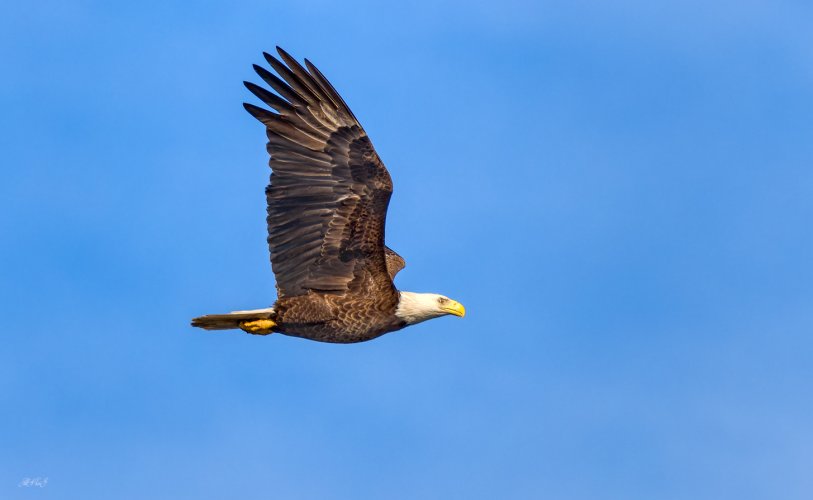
[244,47,403,298]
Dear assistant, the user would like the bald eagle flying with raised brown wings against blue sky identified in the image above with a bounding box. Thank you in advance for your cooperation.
[187,47,465,343]
